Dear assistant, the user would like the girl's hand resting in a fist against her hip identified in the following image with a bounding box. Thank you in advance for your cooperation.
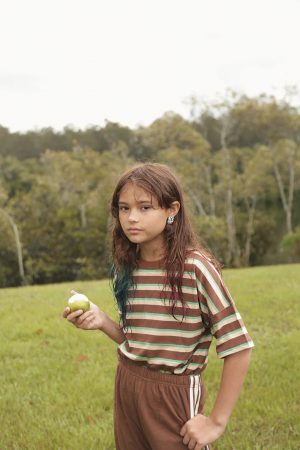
[180,414,225,450]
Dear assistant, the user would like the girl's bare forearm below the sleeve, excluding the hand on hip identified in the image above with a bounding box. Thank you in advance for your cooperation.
[210,349,251,427]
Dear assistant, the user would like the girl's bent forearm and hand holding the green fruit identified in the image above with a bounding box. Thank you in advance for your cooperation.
[63,302,126,344]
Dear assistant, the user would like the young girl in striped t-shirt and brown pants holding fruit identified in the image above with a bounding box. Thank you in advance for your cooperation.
[64,163,254,450]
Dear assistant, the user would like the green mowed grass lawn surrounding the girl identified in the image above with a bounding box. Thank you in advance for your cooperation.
[0,264,300,450]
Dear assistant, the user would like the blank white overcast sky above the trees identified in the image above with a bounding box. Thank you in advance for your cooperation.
[0,0,300,131]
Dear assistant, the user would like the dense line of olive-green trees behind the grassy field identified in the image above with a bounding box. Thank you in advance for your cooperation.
[0,94,300,287]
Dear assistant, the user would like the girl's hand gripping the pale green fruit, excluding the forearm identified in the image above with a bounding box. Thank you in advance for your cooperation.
[63,291,105,330]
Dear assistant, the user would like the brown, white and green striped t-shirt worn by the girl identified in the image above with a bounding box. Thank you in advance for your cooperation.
[119,252,254,375]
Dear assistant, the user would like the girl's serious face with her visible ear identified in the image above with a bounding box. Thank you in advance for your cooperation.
[119,183,179,248]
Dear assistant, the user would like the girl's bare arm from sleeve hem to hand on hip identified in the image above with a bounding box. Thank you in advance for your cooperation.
[180,349,251,450]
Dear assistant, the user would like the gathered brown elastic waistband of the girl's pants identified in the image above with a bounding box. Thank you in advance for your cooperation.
[118,354,201,387]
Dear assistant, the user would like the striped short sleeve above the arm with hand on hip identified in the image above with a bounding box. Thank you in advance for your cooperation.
[194,257,254,358]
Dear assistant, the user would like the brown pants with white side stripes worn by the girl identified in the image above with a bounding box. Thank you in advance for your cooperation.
[114,357,210,450]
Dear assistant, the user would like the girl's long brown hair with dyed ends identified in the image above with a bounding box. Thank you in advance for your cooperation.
[111,163,220,324]
